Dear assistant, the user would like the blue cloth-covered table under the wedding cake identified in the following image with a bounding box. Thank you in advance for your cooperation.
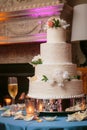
[0,111,87,130]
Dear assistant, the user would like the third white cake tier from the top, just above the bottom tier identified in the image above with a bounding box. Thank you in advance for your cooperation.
[35,63,77,78]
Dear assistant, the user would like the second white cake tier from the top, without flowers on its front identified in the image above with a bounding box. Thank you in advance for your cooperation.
[40,43,72,64]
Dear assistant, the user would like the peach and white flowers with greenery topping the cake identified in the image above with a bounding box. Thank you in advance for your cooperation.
[47,17,70,29]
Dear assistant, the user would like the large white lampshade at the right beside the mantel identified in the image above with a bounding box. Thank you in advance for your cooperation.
[71,4,87,41]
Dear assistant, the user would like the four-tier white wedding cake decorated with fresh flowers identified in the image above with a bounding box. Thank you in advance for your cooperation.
[28,17,83,99]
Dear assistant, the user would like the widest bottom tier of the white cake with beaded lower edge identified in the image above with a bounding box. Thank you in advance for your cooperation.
[28,79,83,99]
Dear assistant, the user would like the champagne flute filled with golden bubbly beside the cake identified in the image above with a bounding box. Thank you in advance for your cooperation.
[8,77,18,104]
